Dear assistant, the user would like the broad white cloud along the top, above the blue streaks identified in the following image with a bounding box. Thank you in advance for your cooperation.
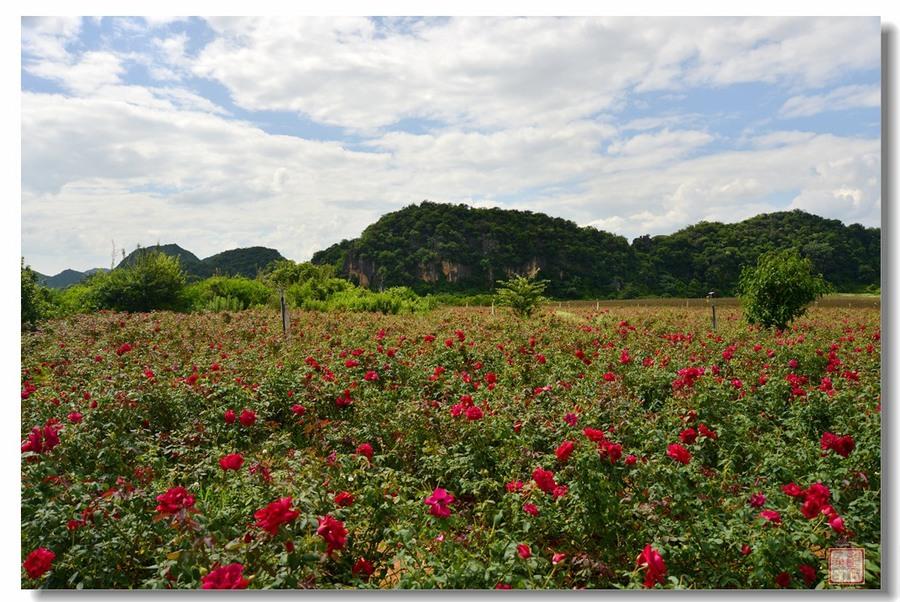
[194,17,880,131]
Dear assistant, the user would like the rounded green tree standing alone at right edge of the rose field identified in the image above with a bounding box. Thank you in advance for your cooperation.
[738,248,829,329]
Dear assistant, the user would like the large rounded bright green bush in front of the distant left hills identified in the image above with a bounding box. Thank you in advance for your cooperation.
[90,250,186,312]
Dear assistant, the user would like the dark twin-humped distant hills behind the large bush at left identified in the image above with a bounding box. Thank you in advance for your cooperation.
[116,244,284,280]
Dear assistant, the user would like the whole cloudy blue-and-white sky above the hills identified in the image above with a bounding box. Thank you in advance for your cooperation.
[21,17,881,274]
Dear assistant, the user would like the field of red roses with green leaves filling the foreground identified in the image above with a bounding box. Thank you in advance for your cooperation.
[21,307,881,589]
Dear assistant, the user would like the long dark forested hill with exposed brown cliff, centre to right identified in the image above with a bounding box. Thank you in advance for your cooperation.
[312,202,881,298]
